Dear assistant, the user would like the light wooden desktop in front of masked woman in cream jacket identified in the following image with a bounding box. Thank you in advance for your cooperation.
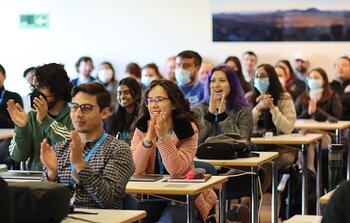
[251,134,322,145]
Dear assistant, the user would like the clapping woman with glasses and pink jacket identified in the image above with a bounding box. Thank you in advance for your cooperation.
[131,80,217,222]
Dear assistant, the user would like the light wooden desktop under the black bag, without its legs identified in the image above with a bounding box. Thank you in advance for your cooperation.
[198,152,278,166]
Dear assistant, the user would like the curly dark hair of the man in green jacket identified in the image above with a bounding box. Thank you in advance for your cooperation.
[34,63,73,102]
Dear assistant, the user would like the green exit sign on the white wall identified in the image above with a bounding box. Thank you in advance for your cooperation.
[19,14,50,29]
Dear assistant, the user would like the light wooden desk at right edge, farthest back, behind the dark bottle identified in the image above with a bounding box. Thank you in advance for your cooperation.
[294,119,350,181]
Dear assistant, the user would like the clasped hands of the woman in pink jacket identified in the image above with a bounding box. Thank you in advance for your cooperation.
[145,112,170,143]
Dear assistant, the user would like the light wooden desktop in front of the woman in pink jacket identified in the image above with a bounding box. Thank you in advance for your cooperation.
[126,176,228,195]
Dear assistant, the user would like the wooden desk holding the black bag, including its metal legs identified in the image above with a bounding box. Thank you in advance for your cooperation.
[198,152,278,222]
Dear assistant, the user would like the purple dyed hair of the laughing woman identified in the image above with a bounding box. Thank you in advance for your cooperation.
[202,64,250,111]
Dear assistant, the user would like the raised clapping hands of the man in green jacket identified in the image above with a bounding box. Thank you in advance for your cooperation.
[7,96,49,128]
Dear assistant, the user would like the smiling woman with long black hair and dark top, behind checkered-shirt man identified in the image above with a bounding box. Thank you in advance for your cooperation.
[105,77,141,145]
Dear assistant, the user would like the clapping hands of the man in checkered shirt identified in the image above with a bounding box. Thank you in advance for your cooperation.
[40,131,86,180]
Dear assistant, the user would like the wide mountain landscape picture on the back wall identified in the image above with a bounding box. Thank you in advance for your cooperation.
[212,0,350,42]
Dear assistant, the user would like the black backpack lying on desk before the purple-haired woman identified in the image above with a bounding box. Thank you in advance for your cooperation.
[196,133,253,159]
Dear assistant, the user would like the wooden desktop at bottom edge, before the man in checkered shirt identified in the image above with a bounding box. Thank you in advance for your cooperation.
[62,208,146,223]
